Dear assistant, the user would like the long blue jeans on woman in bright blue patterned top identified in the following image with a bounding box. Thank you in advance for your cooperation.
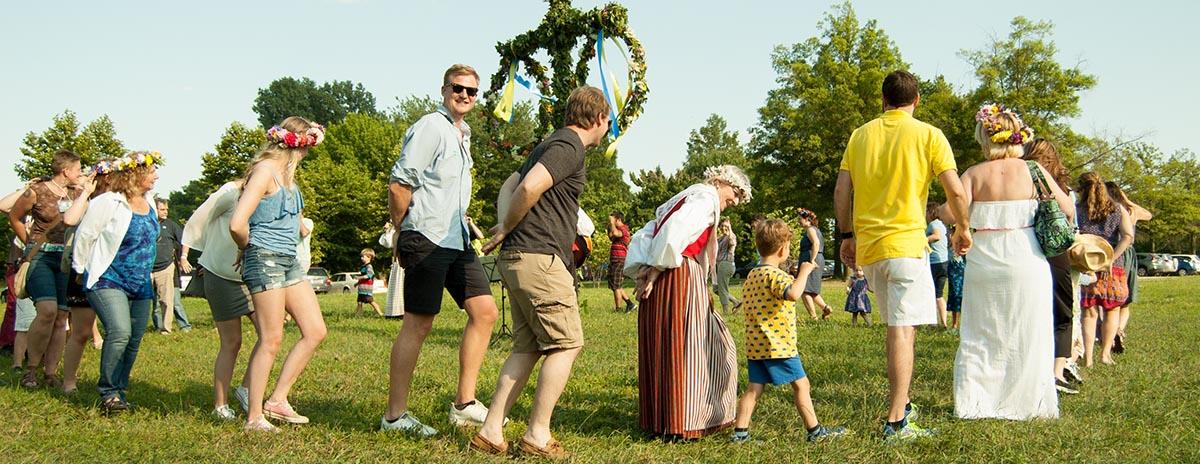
[88,289,152,399]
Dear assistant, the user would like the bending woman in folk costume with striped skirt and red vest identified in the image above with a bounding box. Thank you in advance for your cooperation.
[625,165,751,439]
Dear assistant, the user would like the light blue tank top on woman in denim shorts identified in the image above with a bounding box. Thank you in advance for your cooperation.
[250,175,304,257]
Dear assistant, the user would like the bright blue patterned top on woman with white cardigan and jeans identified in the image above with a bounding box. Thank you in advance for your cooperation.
[91,210,158,300]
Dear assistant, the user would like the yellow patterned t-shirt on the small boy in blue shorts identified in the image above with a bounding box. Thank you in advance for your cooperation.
[742,265,799,360]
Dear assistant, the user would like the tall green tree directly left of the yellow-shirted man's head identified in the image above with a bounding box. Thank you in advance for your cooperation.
[749,2,908,217]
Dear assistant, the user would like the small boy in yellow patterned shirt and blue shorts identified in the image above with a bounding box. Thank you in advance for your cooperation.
[733,219,846,442]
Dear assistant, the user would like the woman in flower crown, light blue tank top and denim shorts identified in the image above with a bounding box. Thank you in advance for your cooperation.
[229,116,325,432]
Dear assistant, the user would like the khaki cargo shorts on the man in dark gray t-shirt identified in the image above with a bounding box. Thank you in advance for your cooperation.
[498,251,583,352]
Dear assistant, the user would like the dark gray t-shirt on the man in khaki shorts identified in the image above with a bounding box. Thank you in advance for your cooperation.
[504,127,588,273]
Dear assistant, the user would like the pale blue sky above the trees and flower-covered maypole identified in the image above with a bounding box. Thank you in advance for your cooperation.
[0,0,1200,192]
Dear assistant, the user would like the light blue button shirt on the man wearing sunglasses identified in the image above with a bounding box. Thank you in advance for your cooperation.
[391,107,473,251]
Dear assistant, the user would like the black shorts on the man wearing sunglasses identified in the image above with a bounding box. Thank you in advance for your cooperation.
[396,230,492,315]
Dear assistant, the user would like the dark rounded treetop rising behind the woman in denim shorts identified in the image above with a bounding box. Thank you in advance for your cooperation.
[252,77,378,127]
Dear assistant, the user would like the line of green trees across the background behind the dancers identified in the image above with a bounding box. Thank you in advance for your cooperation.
[11,2,1200,271]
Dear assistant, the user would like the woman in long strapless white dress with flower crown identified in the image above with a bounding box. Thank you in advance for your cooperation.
[954,104,1074,420]
